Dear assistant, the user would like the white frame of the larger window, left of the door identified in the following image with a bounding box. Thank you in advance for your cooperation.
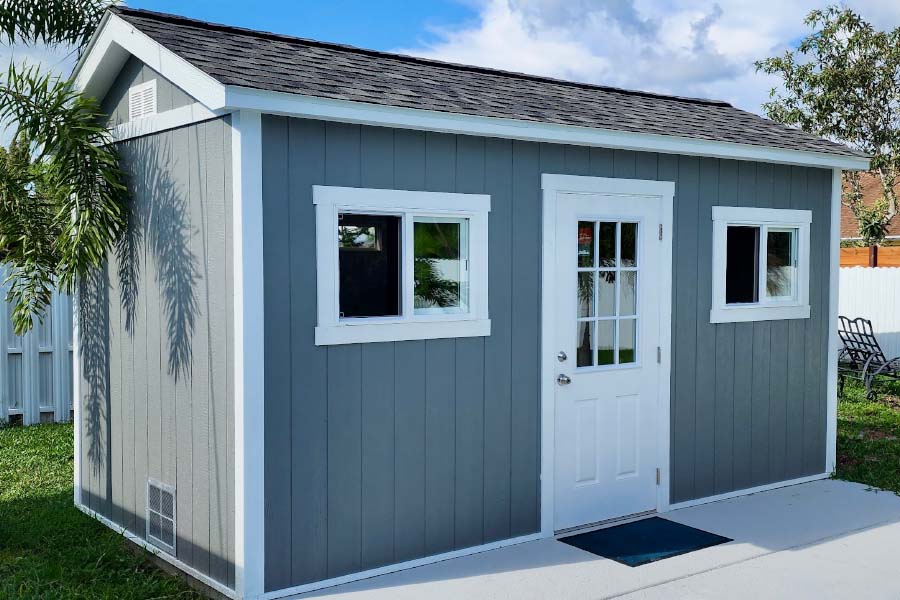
[313,185,491,346]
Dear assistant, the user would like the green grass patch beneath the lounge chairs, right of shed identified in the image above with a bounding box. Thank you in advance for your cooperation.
[835,381,900,494]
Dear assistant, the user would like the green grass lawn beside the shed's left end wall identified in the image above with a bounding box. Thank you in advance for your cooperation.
[0,424,202,600]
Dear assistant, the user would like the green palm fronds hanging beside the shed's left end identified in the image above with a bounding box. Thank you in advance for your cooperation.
[0,0,127,334]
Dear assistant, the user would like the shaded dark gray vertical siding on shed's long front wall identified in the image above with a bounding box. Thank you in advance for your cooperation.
[263,116,830,590]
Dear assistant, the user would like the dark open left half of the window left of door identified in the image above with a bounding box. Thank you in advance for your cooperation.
[338,213,400,317]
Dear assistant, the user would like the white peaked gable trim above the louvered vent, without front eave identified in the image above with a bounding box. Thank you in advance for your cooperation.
[73,13,225,110]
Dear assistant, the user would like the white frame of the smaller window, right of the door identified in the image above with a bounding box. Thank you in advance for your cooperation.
[709,206,812,323]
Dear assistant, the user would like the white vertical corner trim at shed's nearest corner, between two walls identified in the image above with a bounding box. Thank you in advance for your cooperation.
[231,111,265,598]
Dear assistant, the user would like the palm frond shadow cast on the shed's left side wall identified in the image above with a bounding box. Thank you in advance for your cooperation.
[77,131,199,492]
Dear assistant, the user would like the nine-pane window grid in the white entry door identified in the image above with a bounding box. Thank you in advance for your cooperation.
[576,220,640,368]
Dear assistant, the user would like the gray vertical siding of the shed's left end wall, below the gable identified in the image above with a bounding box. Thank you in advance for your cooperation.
[80,119,234,586]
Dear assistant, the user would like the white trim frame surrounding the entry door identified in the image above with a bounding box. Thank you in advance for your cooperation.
[540,173,675,537]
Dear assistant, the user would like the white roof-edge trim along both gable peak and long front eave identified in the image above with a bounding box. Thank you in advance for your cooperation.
[75,13,869,170]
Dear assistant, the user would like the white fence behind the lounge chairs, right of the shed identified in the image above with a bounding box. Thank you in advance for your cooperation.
[838,267,900,358]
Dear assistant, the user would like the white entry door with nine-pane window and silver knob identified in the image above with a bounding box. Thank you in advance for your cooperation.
[554,186,671,531]
